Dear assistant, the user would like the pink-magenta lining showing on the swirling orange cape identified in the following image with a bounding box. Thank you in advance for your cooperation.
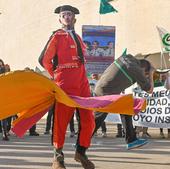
[12,95,145,137]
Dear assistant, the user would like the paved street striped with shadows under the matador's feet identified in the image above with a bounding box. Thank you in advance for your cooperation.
[0,120,170,169]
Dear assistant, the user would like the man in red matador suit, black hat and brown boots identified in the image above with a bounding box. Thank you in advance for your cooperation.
[39,5,95,169]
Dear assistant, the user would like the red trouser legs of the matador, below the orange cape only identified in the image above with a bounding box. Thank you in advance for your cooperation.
[53,103,95,148]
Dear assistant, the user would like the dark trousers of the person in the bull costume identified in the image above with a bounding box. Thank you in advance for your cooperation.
[94,112,137,144]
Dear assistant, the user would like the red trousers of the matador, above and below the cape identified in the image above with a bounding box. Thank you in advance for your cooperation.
[53,66,95,148]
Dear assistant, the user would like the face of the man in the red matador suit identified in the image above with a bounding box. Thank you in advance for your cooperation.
[59,11,75,27]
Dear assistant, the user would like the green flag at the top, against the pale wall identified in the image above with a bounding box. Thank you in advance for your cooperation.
[99,0,118,14]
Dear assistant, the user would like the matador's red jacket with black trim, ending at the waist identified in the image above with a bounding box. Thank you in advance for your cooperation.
[39,29,86,77]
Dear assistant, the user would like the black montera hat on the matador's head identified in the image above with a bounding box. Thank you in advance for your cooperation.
[54,5,80,14]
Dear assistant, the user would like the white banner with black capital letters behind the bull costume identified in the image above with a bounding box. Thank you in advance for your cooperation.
[105,86,170,128]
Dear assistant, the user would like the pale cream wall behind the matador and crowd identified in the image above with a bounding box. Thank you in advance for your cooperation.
[0,0,170,70]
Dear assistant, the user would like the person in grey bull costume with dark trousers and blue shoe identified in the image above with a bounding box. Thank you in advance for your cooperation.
[95,54,154,149]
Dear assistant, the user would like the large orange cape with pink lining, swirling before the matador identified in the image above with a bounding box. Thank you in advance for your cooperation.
[0,71,146,136]
